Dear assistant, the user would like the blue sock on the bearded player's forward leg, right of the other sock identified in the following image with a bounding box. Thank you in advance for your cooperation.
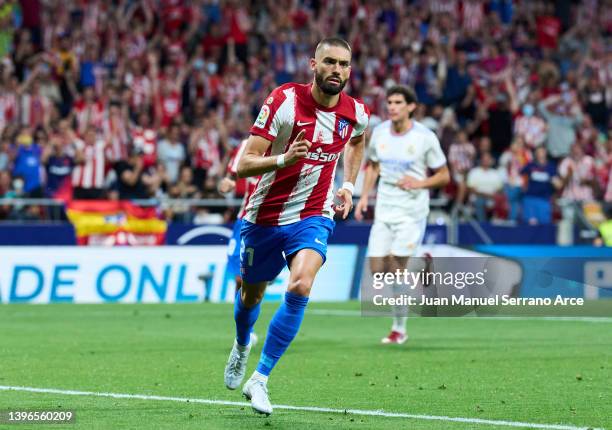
[257,292,308,376]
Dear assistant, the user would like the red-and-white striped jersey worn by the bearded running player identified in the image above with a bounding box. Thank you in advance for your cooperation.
[244,83,370,225]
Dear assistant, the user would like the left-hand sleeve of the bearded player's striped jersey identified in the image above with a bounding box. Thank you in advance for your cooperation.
[251,86,295,141]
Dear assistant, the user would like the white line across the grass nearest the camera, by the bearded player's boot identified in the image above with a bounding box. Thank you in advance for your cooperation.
[0,385,604,430]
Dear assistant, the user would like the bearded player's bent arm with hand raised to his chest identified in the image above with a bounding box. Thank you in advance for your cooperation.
[237,130,312,178]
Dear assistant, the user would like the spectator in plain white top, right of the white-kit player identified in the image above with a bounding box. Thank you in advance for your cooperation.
[467,153,504,221]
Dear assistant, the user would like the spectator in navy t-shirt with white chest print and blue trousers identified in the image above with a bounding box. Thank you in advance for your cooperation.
[521,146,561,224]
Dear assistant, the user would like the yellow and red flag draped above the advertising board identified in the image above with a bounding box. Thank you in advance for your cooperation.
[66,200,167,246]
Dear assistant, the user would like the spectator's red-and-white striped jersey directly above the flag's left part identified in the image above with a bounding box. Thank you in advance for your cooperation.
[72,139,108,188]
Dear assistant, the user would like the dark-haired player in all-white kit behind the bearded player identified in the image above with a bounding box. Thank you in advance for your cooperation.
[355,86,450,344]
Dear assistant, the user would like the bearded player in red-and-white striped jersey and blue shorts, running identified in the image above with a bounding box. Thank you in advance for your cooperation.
[225,38,369,414]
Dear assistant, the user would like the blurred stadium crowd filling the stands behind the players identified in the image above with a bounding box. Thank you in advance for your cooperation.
[0,0,612,227]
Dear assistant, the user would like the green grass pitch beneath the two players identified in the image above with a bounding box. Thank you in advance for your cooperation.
[0,303,612,430]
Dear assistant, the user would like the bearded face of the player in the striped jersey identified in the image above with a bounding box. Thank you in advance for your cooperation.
[310,46,351,96]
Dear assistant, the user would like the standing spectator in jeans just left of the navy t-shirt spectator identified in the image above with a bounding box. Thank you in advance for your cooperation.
[499,136,532,221]
